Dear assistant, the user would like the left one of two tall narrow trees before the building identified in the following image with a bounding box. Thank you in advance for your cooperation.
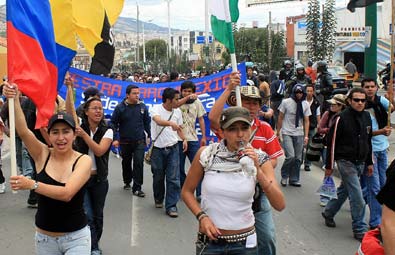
[306,0,323,61]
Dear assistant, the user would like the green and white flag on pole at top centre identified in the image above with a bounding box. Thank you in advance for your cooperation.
[209,0,239,53]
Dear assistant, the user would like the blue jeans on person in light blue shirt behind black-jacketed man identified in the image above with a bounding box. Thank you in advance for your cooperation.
[365,150,388,227]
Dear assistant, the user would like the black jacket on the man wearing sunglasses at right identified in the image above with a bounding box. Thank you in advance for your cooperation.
[326,107,373,169]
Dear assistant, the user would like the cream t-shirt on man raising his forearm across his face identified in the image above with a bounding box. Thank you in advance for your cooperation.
[179,99,206,141]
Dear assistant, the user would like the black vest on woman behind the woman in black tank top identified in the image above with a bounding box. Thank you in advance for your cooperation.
[75,121,110,181]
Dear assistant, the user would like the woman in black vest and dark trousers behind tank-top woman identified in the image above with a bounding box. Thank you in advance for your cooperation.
[76,97,113,255]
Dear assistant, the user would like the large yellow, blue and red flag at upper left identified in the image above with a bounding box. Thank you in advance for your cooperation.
[6,0,124,128]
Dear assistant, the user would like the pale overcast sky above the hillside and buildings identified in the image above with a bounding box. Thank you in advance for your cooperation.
[0,0,348,30]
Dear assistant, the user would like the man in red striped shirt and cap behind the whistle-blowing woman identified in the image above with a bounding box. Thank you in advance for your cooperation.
[209,73,283,255]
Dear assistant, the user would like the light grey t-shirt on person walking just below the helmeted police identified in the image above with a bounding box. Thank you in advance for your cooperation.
[278,98,311,136]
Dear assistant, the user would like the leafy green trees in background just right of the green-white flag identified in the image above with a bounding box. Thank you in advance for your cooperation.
[234,28,286,69]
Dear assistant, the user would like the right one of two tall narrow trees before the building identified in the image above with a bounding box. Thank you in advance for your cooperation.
[320,0,336,62]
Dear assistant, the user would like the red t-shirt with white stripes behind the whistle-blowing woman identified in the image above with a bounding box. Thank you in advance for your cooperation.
[251,118,283,159]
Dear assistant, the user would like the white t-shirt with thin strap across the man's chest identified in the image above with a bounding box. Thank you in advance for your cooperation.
[151,104,183,148]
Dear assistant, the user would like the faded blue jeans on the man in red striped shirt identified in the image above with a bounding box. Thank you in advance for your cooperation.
[254,193,276,255]
